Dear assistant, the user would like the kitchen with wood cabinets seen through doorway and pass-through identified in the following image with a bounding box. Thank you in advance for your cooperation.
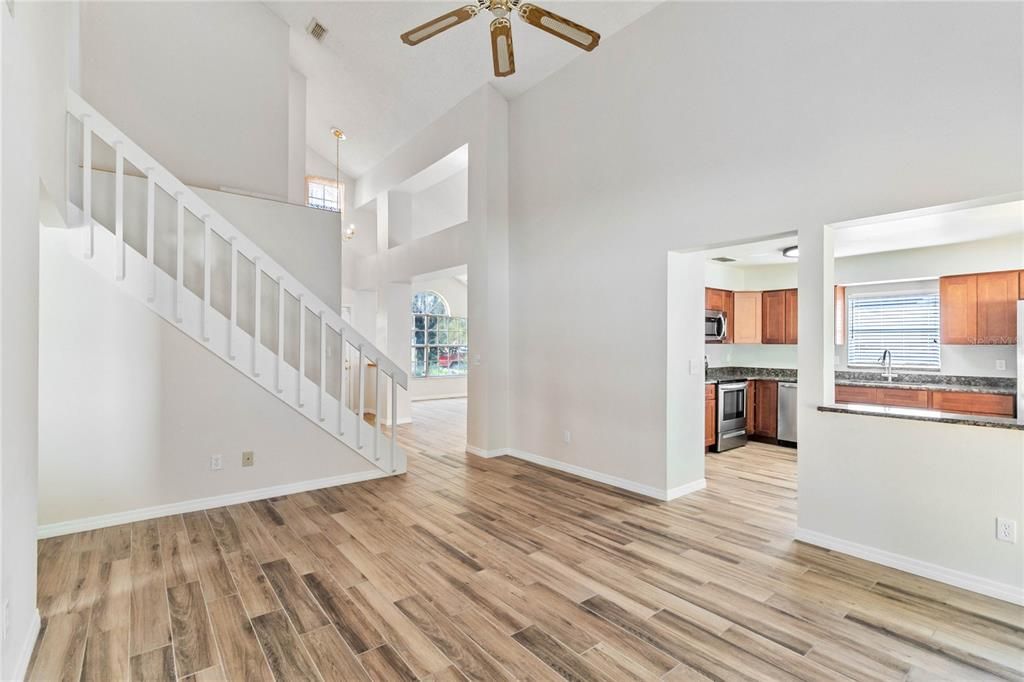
[705,197,1024,453]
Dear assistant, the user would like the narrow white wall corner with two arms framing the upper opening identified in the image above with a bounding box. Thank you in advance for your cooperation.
[354,86,509,453]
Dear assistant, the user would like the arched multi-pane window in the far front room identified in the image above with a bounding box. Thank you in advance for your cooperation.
[412,291,469,377]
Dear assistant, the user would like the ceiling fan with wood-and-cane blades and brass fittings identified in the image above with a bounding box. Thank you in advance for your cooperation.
[401,0,601,78]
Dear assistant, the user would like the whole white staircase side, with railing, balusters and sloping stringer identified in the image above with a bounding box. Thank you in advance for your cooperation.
[65,90,408,474]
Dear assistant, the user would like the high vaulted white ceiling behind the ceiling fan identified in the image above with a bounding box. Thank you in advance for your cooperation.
[266,0,657,177]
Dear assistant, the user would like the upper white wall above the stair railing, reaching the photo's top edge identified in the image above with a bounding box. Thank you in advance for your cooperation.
[81,2,290,199]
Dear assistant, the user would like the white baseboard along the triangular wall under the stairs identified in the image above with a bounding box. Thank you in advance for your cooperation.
[37,470,389,539]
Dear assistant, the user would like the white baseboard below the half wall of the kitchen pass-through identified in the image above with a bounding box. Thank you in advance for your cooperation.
[795,528,1024,605]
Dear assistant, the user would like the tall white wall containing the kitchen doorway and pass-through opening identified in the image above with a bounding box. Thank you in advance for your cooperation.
[512,3,1024,587]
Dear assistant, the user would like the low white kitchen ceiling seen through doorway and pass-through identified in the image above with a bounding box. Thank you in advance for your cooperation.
[707,201,1024,265]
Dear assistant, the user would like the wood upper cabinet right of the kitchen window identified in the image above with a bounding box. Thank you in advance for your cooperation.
[939,270,1021,345]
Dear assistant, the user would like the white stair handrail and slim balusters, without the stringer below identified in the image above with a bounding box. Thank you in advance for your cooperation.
[68,90,409,473]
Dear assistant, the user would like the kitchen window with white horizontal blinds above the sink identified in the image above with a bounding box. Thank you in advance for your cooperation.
[847,293,940,370]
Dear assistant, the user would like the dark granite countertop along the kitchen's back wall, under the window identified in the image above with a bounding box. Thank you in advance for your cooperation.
[705,367,1017,395]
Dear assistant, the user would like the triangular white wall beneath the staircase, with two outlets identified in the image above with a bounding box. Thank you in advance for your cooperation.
[39,230,375,524]
